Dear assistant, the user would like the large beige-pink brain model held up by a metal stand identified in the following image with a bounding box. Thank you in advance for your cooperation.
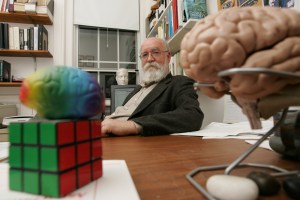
[181,7,300,100]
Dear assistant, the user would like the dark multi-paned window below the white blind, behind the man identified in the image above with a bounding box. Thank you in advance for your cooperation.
[77,26,138,98]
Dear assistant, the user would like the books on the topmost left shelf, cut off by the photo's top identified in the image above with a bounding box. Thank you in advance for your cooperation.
[0,0,54,18]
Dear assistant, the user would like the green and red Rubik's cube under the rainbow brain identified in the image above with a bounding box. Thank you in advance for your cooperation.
[9,120,103,197]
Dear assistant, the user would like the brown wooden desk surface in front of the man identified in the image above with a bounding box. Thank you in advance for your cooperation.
[103,136,300,200]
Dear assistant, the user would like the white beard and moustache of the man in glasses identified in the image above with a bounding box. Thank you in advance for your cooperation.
[142,62,169,85]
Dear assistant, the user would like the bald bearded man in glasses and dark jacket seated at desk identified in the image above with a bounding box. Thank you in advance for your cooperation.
[101,38,204,136]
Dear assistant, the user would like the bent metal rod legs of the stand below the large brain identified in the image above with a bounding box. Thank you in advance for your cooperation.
[186,108,300,200]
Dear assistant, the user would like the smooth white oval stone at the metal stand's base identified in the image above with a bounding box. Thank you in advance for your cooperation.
[206,175,259,200]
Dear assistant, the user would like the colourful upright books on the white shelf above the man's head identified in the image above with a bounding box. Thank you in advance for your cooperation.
[148,0,208,40]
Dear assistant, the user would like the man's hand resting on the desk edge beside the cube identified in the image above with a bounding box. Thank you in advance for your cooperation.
[101,119,139,136]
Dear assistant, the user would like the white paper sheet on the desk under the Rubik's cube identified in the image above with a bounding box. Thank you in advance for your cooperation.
[0,160,140,200]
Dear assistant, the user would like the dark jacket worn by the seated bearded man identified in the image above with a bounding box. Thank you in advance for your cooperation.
[123,74,204,136]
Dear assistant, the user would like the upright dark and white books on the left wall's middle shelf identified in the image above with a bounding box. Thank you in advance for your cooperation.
[0,23,48,50]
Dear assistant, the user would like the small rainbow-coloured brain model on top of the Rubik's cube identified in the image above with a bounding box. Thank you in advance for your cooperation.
[20,66,104,119]
